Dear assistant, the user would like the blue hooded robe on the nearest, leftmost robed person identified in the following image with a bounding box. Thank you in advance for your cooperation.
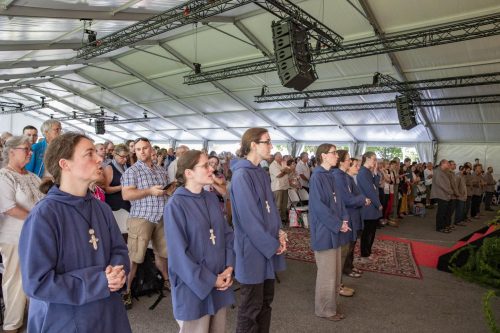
[19,186,131,333]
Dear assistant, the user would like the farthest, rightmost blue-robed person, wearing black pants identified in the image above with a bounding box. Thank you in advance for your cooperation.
[357,151,383,261]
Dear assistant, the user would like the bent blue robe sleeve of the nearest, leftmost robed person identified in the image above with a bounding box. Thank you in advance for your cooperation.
[19,210,110,305]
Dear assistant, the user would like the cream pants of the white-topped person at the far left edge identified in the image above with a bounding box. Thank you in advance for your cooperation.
[0,244,26,330]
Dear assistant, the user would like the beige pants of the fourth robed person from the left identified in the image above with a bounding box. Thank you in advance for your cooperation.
[314,248,342,317]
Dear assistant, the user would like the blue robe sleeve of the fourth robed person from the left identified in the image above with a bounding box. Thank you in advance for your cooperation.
[309,177,342,234]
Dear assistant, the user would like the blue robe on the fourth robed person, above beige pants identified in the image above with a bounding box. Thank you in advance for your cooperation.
[309,166,349,251]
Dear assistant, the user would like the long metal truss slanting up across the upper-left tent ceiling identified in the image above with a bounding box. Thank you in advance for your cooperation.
[77,0,254,59]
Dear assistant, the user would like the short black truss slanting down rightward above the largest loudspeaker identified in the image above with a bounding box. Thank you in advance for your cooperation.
[255,0,344,48]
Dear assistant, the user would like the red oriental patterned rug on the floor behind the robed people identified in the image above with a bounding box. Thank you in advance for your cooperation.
[285,228,422,279]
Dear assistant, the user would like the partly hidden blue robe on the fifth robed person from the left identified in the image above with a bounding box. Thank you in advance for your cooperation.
[332,168,366,241]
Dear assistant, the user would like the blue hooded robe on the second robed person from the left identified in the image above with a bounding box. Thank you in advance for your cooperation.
[164,187,234,321]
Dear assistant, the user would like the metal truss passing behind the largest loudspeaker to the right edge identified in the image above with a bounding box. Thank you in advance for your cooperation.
[184,14,500,85]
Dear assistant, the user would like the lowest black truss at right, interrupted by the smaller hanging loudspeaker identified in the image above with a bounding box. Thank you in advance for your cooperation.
[299,95,500,113]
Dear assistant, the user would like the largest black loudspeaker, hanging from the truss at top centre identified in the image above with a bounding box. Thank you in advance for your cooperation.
[271,20,318,91]
